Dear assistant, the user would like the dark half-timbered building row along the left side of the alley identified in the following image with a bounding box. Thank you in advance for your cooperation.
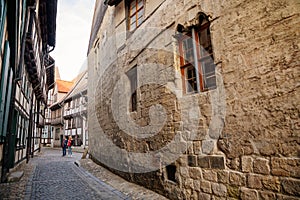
[0,0,57,182]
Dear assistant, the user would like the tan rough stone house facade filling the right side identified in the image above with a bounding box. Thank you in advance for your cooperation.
[88,0,300,200]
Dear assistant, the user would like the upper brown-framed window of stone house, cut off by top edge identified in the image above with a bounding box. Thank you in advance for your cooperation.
[128,0,144,31]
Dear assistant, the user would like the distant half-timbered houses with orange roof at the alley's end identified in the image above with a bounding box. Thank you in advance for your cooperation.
[48,69,88,148]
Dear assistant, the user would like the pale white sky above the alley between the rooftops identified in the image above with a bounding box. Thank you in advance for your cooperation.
[50,0,95,81]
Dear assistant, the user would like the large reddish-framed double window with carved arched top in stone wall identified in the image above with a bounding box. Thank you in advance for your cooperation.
[178,14,216,94]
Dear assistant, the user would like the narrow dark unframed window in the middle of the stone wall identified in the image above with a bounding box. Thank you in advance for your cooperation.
[127,66,137,112]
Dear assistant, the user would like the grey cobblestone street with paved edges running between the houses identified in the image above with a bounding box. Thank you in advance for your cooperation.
[0,148,165,200]
